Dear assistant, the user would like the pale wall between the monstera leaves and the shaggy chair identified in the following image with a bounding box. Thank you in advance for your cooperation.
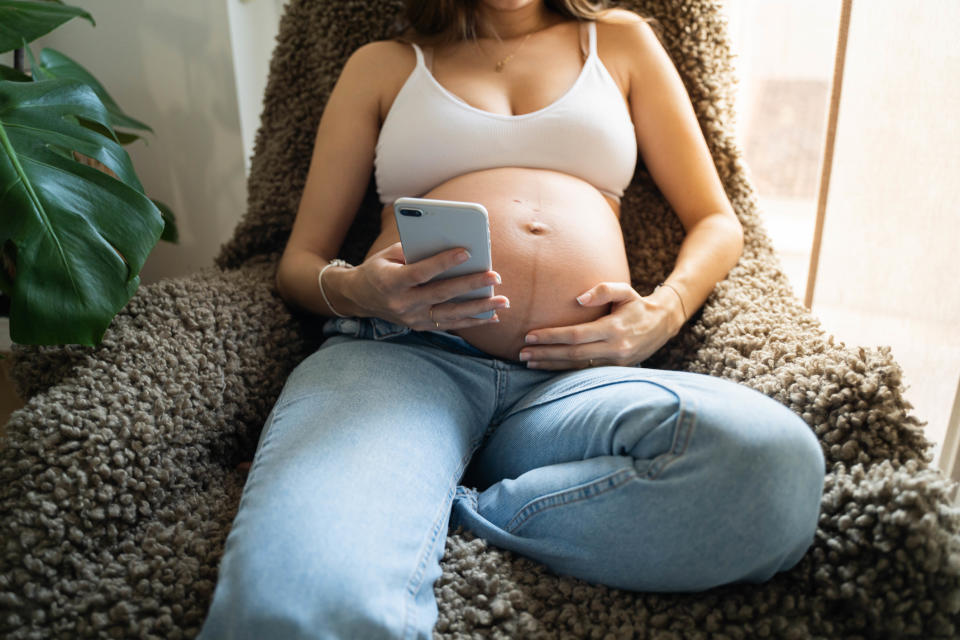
[29,0,246,283]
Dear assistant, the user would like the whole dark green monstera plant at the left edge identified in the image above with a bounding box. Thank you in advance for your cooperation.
[0,0,176,345]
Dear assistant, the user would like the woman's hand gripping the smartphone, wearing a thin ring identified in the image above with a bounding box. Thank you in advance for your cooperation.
[332,242,510,331]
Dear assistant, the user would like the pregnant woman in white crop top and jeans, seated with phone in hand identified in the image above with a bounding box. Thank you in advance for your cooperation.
[201,0,825,639]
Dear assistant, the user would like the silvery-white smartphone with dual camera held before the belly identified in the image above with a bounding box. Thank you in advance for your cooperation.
[393,198,493,319]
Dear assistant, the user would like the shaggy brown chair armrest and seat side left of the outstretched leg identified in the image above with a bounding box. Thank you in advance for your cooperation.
[0,264,319,637]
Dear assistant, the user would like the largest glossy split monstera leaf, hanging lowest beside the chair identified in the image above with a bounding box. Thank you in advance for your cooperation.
[0,79,164,345]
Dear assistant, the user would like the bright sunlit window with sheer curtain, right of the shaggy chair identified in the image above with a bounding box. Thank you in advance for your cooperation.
[726,0,960,478]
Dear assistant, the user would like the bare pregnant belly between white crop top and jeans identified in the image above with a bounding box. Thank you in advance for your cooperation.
[368,167,630,360]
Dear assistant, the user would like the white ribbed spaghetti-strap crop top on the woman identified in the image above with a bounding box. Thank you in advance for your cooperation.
[374,21,637,204]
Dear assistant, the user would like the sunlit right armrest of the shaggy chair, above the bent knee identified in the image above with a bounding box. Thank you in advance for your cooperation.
[655,255,933,467]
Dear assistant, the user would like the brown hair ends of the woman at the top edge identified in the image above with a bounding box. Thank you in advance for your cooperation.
[390,0,659,45]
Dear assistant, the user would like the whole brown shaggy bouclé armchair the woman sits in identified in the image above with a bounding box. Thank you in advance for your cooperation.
[0,0,960,640]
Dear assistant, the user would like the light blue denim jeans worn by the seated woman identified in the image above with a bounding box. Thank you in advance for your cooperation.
[201,318,825,639]
